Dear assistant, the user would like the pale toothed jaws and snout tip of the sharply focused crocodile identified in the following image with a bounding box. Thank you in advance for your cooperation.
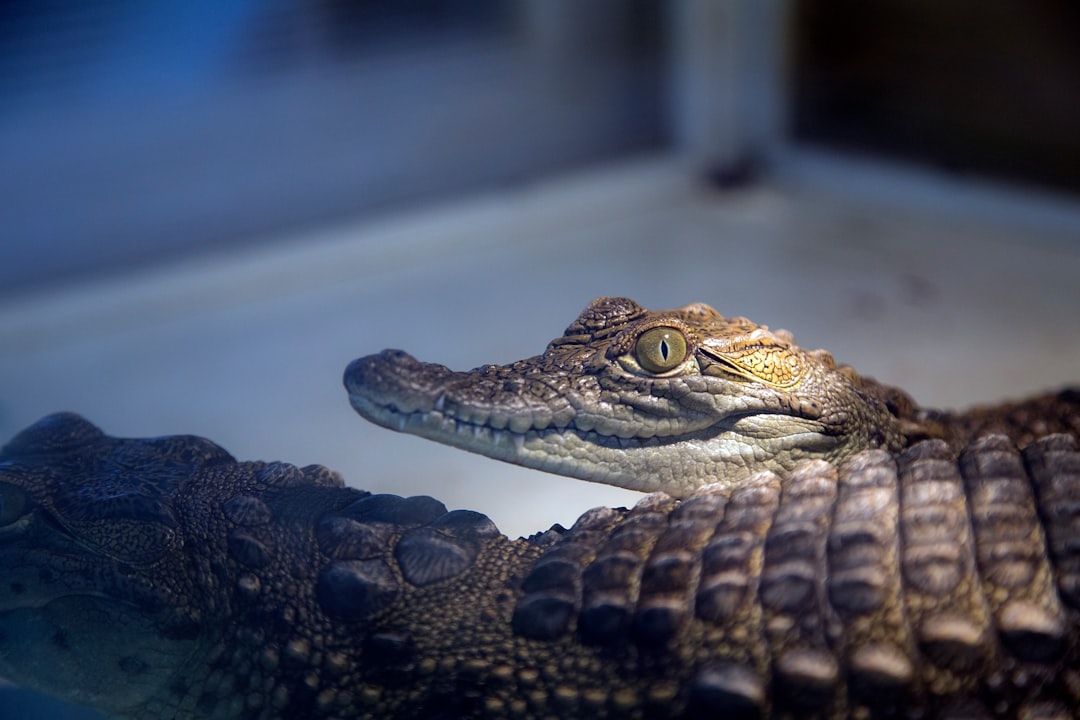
[345,351,846,497]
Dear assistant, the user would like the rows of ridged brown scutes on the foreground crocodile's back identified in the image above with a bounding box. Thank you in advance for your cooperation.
[514,435,1080,718]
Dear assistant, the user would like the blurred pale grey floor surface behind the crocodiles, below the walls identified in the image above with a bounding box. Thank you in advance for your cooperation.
[0,159,1080,535]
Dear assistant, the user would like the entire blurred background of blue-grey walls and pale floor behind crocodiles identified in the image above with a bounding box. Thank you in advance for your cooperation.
[0,0,1080,718]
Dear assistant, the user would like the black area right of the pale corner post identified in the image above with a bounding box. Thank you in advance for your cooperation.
[793,0,1080,192]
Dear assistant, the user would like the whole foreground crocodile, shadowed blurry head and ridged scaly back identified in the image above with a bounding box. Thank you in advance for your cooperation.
[0,415,1080,719]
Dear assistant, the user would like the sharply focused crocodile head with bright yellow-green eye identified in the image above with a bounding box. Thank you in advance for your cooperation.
[345,298,903,497]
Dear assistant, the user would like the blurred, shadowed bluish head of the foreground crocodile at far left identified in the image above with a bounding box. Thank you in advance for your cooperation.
[0,413,224,716]
